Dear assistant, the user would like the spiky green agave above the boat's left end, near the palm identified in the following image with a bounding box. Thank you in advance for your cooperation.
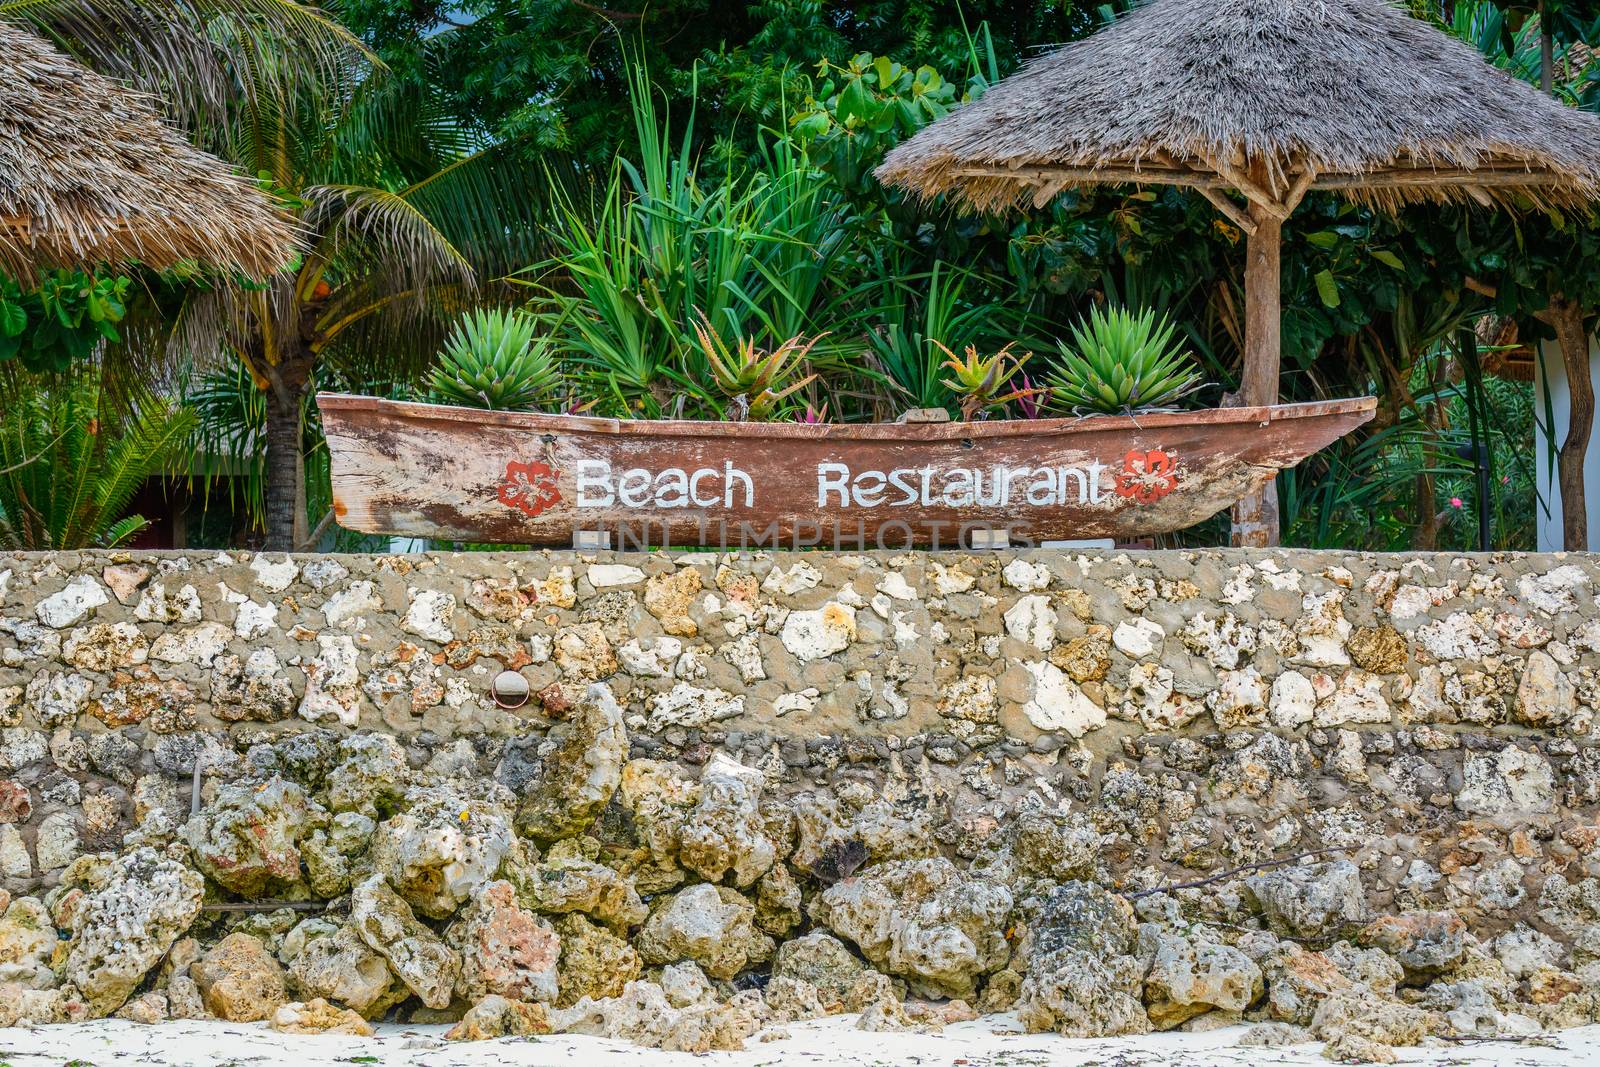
[427,309,562,411]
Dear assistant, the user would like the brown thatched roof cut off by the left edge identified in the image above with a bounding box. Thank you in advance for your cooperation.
[0,21,294,278]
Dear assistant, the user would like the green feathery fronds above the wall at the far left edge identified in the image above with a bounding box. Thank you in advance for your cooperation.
[0,365,194,552]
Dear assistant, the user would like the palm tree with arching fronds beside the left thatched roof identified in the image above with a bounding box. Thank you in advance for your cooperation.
[0,0,542,549]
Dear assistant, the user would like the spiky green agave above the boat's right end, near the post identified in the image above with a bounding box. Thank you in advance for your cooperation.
[1050,309,1203,414]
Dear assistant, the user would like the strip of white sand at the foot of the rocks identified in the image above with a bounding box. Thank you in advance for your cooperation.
[0,1016,1600,1067]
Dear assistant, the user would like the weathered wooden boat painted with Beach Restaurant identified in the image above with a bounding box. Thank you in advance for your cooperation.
[317,394,1378,547]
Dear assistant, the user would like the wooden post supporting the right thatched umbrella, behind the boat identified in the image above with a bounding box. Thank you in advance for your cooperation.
[1229,205,1283,549]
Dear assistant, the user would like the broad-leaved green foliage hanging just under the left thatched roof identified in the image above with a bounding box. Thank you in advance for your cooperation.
[0,270,130,373]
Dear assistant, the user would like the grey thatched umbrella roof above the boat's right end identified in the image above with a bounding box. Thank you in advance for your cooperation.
[878,0,1600,210]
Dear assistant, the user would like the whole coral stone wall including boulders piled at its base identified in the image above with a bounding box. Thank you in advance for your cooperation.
[9,552,1600,1059]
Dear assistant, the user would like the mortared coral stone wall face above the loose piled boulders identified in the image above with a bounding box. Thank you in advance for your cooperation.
[0,552,1600,920]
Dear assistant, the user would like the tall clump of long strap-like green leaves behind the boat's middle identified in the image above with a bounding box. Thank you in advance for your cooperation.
[525,58,848,416]
